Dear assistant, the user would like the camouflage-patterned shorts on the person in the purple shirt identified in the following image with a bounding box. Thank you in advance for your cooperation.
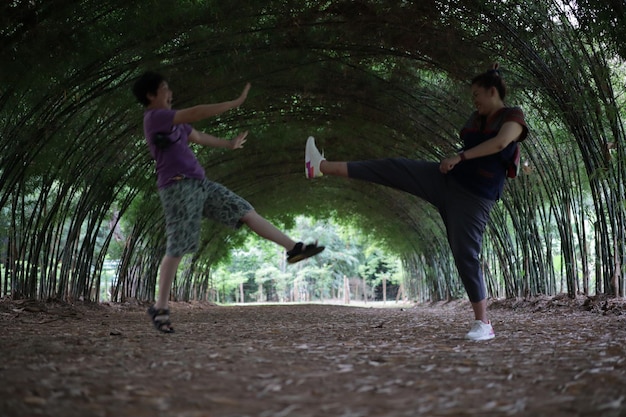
[159,179,254,257]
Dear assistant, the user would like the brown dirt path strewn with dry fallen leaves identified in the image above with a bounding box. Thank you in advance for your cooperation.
[0,299,626,417]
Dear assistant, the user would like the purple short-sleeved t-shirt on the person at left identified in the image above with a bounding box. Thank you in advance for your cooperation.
[143,109,205,189]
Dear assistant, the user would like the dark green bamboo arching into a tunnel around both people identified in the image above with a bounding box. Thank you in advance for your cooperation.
[0,0,626,301]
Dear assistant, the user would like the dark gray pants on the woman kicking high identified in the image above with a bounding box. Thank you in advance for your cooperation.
[348,158,495,303]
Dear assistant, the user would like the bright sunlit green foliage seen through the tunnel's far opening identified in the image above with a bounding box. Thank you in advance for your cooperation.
[212,216,400,302]
